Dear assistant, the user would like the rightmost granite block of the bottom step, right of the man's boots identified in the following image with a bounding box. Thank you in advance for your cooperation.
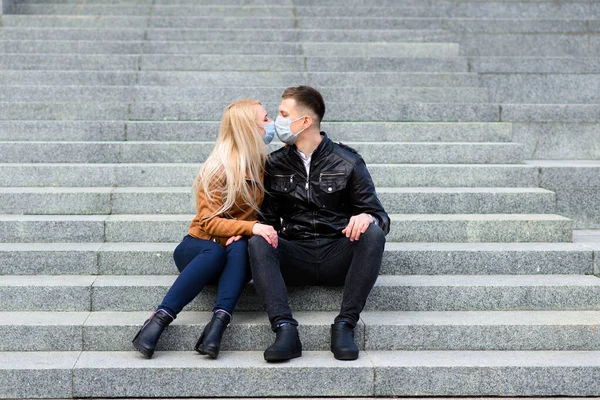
[376,351,600,396]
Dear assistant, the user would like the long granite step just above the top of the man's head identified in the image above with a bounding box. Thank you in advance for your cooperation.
[0,70,479,88]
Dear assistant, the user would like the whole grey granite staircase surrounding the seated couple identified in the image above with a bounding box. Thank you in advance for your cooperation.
[0,0,600,398]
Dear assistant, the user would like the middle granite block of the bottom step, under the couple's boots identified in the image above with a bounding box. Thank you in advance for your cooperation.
[73,352,374,397]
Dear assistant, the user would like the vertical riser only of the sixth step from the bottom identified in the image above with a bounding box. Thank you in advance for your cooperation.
[0,189,555,215]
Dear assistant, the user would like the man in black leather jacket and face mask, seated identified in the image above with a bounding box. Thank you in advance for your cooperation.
[248,86,390,361]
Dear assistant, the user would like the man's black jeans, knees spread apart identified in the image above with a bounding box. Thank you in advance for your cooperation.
[248,224,385,330]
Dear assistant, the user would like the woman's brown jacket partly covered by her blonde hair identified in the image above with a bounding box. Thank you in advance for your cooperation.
[188,175,264,247]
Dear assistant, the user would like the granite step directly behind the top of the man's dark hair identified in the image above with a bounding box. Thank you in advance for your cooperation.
[0,85,489,103]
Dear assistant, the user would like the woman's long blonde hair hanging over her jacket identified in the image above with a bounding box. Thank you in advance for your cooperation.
[193,99,268,218]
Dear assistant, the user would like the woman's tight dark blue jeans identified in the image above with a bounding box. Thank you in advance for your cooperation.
[158,235,251,317]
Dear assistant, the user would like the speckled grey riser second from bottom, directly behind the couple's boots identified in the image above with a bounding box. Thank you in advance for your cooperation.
[0,314,600,351]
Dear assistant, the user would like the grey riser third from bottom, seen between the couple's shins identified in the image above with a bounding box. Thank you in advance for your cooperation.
[0,278,600,312]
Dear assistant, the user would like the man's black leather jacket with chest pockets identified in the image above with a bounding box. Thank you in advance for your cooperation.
[259,132,390,240]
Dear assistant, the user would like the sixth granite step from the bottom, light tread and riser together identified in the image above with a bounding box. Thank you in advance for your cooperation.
[0,187,556,215]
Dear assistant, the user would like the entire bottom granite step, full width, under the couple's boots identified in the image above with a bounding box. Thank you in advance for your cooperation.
[0,351,600,398]
